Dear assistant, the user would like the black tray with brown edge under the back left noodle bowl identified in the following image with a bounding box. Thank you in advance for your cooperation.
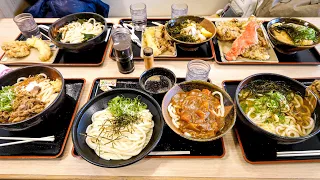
[0,23,113,67]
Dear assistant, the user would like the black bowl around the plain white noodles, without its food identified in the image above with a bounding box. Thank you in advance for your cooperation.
[72,88,164,168]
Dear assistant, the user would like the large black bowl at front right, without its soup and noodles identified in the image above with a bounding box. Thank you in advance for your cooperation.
[235,73,320,144]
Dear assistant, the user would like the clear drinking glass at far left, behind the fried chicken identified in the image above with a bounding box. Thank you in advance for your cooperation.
[13,13,41,38]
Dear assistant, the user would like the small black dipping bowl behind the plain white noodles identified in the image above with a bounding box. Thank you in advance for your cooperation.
[139,67,177,95]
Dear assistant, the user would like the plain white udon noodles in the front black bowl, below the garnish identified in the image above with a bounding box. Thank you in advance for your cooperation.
[86,109,154,160]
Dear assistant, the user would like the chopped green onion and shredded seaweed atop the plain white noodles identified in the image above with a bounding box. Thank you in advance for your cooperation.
[108,96,147,134]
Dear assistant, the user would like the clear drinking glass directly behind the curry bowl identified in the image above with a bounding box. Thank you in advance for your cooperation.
[186,60,211,81]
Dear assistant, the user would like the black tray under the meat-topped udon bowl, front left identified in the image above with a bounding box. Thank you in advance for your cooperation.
[0,79,85,159]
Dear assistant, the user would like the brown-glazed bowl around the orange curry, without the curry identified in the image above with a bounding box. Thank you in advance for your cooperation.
[162,80,236,142]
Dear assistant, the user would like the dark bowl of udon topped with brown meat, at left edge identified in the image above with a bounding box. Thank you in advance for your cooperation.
[0,66,66,131]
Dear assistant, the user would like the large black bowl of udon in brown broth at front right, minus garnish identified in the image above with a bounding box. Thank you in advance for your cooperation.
[235,73,320,144]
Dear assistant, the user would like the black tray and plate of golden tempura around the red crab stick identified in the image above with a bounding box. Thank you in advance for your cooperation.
[213,17,320,65]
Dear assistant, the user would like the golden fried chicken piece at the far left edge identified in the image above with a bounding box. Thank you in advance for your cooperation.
[1,41,30,58]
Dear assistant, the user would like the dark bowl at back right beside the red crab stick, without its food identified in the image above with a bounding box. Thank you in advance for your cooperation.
[267,18,320,54]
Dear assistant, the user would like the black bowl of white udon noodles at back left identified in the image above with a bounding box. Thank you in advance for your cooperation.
[48,12,108,53]
